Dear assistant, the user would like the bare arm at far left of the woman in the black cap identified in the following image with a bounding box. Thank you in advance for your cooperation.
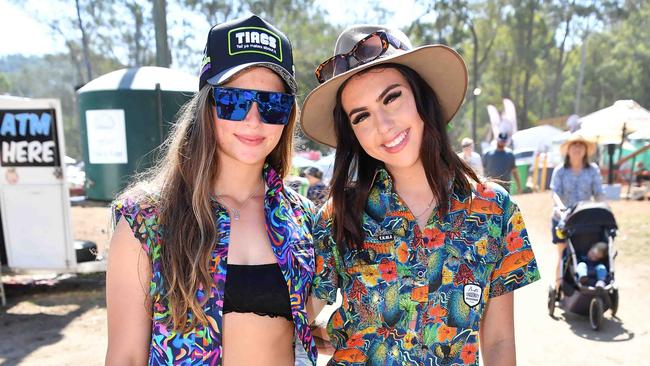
[106,218,151,366]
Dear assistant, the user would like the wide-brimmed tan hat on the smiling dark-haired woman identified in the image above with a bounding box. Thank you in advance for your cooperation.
[300,25,467,147]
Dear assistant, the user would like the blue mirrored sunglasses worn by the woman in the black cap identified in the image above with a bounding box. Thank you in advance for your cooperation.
[212,86,295,125]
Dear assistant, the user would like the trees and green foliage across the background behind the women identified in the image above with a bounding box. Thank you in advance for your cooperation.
[0,0,650,157]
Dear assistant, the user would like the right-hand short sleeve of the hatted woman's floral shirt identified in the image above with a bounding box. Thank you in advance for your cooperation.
[489,196,540,297]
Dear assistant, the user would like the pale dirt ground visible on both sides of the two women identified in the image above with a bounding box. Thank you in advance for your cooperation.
[0,193,650,366]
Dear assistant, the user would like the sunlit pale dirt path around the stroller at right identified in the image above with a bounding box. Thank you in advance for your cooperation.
[515,194,650,366]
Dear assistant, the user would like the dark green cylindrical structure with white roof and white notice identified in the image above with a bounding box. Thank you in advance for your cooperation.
[77,66,199,201]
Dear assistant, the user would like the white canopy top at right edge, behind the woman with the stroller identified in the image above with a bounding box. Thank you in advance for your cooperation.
[579,100,650,144]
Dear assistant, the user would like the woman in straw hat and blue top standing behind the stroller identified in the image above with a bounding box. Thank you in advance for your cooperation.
[551,133,604,289]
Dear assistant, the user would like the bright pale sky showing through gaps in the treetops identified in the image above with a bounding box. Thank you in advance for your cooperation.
[0,0,428,56]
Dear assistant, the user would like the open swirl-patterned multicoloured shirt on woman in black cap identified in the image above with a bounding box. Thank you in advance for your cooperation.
[114,165,316,365]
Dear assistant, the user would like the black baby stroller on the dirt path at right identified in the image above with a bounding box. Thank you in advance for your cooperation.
[548,202,618,330]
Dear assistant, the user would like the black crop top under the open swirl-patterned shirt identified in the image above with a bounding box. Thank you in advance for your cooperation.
[223,263,293,321]
